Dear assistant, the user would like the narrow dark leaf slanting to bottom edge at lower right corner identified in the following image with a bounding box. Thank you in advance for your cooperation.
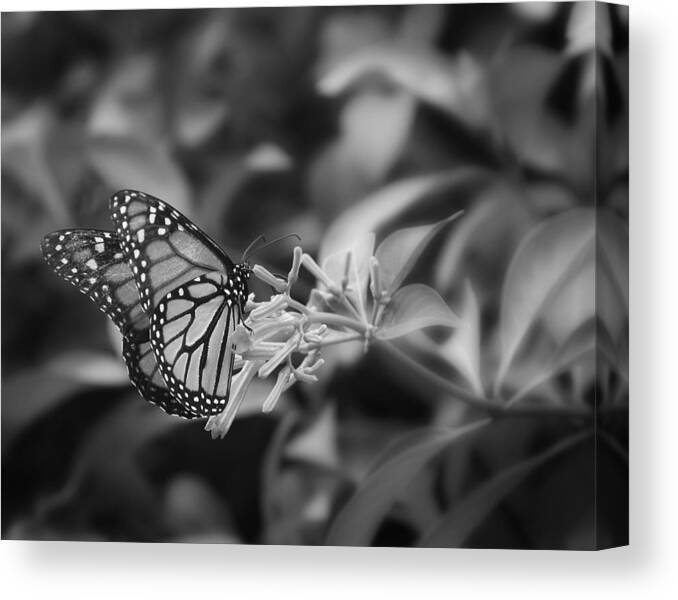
[418,431,591,548]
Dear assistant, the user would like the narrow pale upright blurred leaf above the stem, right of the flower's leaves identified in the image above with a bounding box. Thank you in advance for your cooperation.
[439,279,484,396]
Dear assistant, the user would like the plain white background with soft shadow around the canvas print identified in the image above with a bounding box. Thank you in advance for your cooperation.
[5,0,678,600]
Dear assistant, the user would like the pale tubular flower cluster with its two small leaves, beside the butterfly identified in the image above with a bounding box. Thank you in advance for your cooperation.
[205,214,458,438]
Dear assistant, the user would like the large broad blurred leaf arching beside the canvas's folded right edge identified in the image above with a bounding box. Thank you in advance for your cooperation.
[495,209,595,390]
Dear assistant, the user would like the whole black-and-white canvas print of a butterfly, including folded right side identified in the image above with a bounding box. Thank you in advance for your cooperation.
[1,2,629,550]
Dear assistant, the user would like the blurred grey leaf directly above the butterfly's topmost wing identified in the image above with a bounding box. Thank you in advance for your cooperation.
[88,137,191,214]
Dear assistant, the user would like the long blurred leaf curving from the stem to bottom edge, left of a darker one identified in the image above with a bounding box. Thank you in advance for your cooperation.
[326,419,490,546]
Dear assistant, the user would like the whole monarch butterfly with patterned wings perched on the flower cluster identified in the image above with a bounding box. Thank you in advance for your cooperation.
[42,190,263,418]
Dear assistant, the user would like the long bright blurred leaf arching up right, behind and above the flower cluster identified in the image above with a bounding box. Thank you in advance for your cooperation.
[319,167,488,261]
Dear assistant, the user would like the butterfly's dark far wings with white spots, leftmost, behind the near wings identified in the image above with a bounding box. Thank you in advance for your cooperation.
[42,229,193,418]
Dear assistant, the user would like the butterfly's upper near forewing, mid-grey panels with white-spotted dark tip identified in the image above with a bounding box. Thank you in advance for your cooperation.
[110,190,234,314]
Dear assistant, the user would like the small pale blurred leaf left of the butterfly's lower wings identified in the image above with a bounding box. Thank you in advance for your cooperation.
[45,350,128,386]
